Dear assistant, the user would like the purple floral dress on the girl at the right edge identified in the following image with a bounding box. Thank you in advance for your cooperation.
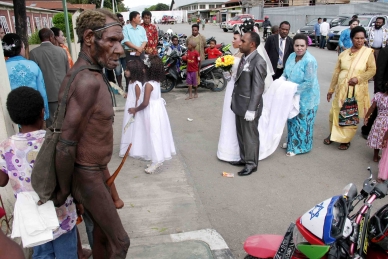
[367,93,388,149]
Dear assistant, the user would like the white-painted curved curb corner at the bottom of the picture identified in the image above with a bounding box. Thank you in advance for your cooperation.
[170,231,235,259]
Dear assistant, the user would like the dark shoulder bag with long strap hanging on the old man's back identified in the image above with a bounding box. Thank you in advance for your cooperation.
[31,65,101,203]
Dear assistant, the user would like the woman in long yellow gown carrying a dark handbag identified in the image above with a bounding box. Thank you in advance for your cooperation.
[323,26,376,150]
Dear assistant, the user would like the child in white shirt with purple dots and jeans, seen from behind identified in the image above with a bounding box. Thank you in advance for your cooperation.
[0,86,78,259]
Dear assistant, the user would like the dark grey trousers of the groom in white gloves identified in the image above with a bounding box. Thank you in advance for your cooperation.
[236,115,260,169]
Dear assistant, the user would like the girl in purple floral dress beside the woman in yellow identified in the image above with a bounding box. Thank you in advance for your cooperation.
[364,85,388,162]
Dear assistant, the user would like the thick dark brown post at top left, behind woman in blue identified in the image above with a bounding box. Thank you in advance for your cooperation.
[13,0,29,59]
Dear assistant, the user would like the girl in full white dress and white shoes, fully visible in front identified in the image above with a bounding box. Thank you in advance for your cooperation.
[128,56,176,174]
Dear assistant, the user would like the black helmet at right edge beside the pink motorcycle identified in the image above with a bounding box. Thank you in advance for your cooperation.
[368,204,388,251]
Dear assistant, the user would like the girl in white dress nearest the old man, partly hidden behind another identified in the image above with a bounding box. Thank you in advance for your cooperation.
[119,60,144,157]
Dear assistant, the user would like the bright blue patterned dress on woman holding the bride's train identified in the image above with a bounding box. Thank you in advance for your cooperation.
[283,51,320,154]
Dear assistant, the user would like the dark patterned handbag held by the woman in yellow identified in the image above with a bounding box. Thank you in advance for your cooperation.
[338,86,360,126]
